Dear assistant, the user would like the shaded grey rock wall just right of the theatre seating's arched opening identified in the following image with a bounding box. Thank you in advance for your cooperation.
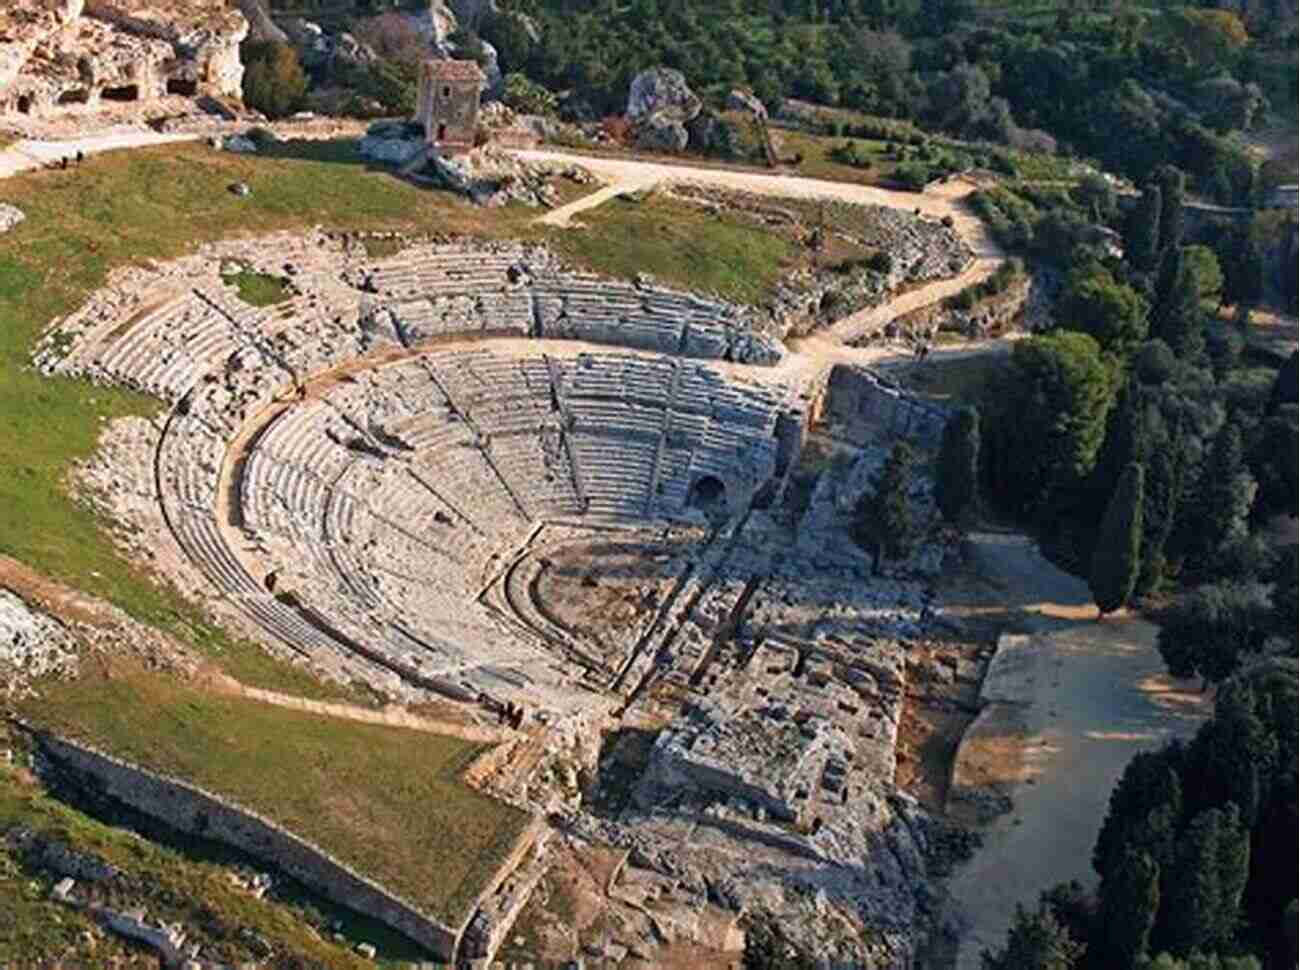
[822,364,948,447]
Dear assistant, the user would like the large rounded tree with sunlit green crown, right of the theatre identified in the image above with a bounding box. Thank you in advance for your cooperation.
[985,330,1115,515]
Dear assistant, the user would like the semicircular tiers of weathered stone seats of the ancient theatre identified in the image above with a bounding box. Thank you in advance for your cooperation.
[68,241,783,710]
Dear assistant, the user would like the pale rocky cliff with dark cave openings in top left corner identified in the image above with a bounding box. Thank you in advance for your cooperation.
[0,0,248,118]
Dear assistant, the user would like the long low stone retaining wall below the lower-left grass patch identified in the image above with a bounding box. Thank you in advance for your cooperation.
[36,732,460,961]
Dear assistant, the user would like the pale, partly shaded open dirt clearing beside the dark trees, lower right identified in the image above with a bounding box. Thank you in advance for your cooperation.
[945,533,1209,970]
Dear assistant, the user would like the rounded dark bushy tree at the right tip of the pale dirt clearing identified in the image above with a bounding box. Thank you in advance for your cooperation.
[1156,583,1269,685]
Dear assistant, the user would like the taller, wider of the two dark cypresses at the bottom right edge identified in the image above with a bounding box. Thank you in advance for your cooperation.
[1161,805,1251,954]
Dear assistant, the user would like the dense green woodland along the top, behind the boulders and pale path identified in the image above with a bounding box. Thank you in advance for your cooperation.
[486,0,1294,202]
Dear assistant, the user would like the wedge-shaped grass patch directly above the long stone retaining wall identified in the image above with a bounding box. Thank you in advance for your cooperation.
[26,671,528,922]
